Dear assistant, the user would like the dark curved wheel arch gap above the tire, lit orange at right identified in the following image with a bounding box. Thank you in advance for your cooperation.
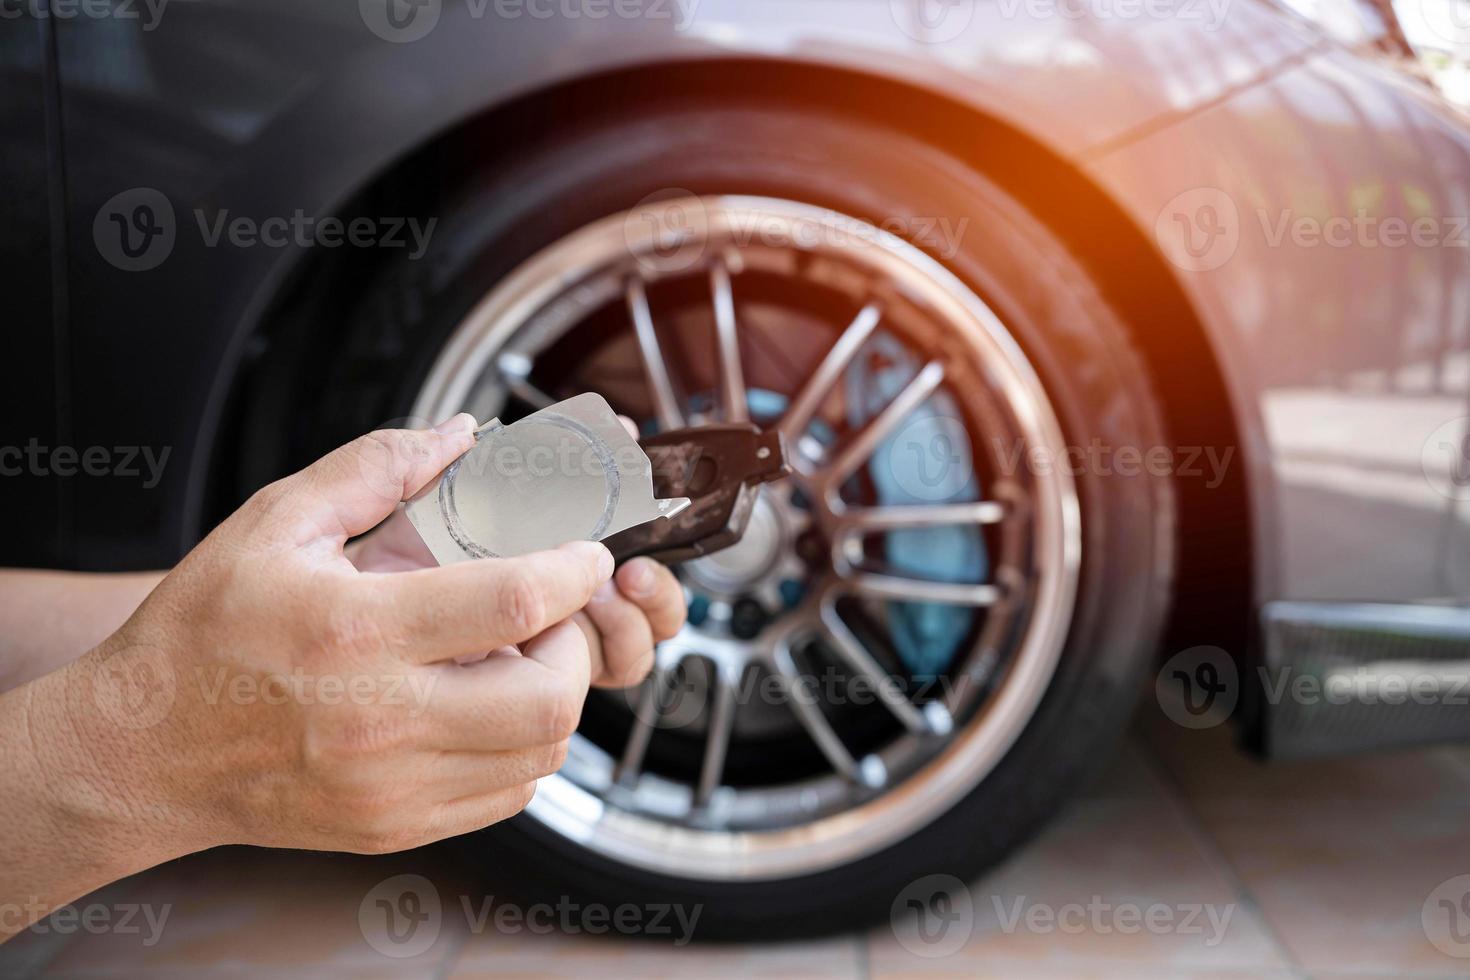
[214,60,1255,667]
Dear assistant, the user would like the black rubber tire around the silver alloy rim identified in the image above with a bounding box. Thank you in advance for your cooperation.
[295,104,1175,939]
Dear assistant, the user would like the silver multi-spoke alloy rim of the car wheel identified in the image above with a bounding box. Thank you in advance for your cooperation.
[413,195,1080,880]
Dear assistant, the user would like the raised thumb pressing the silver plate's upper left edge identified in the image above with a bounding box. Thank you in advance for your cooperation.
[290,413,476,538]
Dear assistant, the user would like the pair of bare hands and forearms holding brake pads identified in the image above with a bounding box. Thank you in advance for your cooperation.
[0,416,684,937]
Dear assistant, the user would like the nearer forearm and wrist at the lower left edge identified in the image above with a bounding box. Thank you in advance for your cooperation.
[0,648,198,942]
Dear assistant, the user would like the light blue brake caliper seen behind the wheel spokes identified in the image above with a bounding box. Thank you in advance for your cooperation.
[844,334,988,682]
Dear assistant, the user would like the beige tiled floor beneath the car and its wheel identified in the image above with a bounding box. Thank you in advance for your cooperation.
[0,718,1470,980]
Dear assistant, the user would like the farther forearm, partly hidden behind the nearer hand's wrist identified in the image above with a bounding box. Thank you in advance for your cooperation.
[0,569,163,691]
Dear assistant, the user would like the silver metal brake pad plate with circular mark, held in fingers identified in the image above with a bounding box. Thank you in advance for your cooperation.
[407,392,689,564]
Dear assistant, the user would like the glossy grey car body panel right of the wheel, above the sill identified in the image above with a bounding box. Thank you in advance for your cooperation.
[1089,45,1470,602]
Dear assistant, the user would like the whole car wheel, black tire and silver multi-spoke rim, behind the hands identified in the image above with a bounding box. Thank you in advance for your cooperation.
[252,107,1173,937]
